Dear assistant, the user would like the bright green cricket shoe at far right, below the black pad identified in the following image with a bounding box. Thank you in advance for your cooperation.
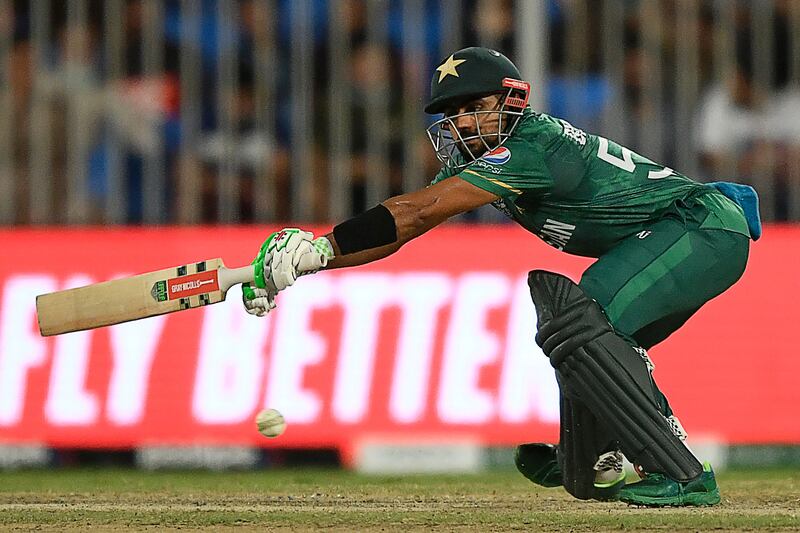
[619,462,720,507]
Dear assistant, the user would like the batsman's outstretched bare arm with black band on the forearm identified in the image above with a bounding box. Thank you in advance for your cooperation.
[325,177,497,268]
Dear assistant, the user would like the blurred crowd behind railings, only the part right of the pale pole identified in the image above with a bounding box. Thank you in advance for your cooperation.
[548,0,800,221]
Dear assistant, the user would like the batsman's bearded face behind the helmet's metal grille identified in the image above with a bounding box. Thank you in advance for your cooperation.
[442,94,503,158]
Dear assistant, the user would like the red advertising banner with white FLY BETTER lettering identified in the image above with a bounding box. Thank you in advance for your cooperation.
[0,226,800,448]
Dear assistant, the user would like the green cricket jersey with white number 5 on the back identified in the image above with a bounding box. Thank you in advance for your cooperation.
[433,110,749,257]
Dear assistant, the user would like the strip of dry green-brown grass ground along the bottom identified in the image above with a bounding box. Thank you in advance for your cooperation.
[0,469,800,532]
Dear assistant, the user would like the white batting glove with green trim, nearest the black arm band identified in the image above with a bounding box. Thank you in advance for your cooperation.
[253,228,333,294]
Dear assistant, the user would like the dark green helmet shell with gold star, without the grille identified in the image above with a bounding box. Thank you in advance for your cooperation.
[425,46,522,114]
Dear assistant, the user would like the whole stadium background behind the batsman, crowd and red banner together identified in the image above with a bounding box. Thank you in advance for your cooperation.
[0,0,800,471]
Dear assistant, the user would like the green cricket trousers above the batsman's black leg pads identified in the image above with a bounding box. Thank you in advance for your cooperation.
[580,193,750,349]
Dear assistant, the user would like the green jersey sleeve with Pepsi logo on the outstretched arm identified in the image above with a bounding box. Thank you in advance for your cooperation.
[458,139,553,200]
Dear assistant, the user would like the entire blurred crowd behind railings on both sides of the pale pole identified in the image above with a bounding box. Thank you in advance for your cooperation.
[0,0,800,224]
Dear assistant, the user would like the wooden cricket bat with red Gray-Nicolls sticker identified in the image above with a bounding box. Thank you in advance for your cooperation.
[36,254,327,337]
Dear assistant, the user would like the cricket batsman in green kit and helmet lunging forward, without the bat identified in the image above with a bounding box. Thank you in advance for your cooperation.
[243,47,761,506]
